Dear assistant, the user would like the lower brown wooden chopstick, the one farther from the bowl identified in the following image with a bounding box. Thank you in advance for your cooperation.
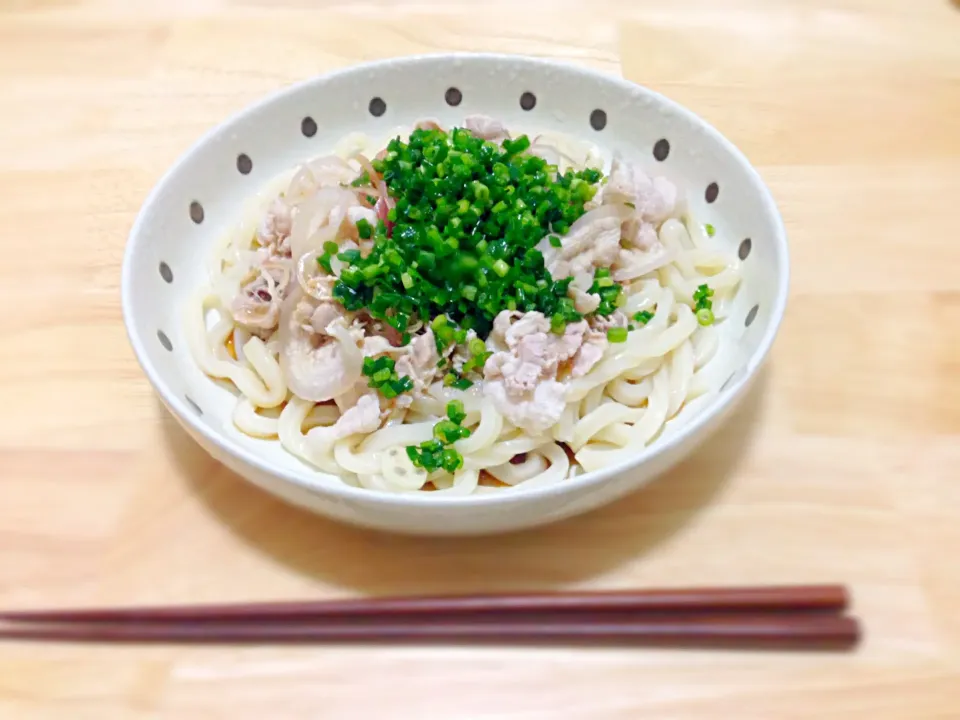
[0,612,860,649]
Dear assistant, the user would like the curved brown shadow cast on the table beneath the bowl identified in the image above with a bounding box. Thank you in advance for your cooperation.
[163,371,767,595]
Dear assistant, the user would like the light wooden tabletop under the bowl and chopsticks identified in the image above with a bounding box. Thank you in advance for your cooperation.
[0,0,960,720]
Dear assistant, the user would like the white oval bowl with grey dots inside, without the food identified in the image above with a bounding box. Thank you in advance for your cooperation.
[122,54,789,535]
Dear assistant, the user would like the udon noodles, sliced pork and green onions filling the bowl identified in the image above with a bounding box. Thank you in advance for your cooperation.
[185,116,741,495]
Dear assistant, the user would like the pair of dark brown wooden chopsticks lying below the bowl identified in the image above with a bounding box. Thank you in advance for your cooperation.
[0,585,860,649]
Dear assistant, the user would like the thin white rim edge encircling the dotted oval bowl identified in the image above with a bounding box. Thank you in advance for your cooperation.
[120,52,790,512]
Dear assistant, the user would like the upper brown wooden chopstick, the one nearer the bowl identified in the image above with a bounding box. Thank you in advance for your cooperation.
[0,585,849,622]
